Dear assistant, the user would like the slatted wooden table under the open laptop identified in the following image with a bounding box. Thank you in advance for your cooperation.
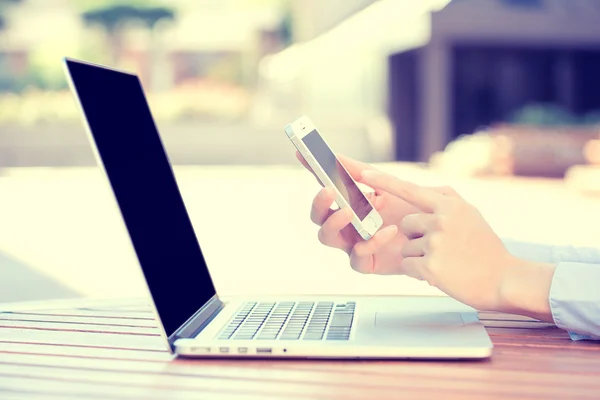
[0,300,600,399]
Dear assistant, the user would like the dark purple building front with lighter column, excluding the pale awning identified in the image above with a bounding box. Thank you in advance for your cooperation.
[389,0,600,160]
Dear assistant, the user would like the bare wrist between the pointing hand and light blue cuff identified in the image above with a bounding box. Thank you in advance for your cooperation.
[497,257,556,322]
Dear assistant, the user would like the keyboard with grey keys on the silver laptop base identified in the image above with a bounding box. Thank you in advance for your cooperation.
[218,301,356,340]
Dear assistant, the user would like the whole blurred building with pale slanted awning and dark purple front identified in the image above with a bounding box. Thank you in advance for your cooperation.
[261,0,600,161]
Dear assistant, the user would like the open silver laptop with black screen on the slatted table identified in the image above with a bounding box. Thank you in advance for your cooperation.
[65,59,492,359]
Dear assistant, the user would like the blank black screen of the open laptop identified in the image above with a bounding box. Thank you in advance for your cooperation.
[67,60,215,336]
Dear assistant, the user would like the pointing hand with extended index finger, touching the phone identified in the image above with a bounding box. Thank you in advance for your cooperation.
[362,170,519,310]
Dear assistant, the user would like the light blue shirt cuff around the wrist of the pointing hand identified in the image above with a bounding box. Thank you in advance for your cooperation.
[550,262,600,340]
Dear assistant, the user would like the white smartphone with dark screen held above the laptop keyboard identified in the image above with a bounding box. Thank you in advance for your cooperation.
[285,116,383,240]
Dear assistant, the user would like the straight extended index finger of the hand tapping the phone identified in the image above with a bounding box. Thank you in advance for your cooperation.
[361,169,443,212]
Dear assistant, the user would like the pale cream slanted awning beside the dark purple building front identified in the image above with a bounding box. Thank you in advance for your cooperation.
[253,0,448,161]
